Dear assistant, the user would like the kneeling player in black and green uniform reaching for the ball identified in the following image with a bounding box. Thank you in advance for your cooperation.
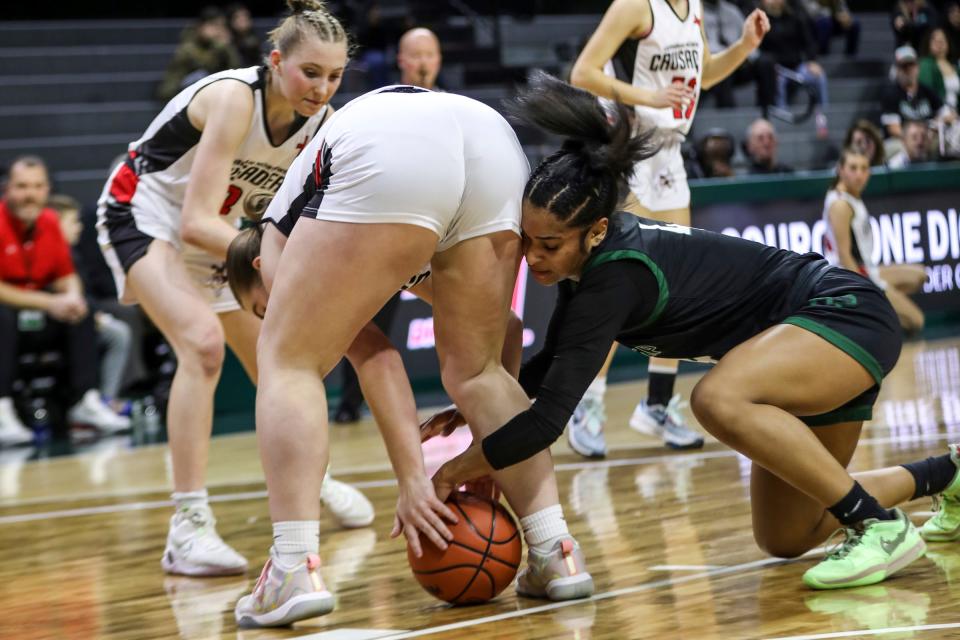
[434,74,960,589]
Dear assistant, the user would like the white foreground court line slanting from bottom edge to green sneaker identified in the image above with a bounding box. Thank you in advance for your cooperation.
[383,547,823,640]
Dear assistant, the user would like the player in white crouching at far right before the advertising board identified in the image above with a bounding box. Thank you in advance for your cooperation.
[823,147,927,332]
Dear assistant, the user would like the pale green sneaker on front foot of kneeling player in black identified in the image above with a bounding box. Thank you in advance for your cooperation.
[803,509,927,589]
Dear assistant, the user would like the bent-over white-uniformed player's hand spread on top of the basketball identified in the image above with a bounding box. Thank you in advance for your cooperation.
[390,476,457,558]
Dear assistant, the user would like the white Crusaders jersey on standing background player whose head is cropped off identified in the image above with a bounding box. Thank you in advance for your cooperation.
[604,0,703,135]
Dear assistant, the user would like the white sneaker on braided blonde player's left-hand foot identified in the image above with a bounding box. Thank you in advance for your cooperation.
[160,504,247,576]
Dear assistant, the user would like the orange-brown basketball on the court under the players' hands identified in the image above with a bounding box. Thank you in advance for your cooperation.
[407,493,523,604]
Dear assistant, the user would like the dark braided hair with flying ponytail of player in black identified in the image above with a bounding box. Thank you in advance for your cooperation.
[505,71,660,227]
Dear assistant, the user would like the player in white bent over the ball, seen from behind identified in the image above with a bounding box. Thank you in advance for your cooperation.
[231,86,593,626]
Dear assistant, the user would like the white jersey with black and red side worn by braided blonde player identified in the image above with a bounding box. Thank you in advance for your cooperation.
[100,67,329,251]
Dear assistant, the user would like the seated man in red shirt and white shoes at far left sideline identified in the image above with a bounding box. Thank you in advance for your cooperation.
[0,156,130,443]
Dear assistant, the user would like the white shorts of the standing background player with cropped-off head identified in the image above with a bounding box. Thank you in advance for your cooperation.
[630,135,690,211]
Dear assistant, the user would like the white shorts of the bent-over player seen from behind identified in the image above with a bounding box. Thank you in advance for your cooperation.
[264,87,530,251]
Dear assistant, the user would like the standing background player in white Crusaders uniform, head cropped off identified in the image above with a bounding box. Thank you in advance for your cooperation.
[567,0,770,457]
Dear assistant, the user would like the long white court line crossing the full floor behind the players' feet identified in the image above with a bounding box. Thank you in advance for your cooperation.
[0,433,956,525]
